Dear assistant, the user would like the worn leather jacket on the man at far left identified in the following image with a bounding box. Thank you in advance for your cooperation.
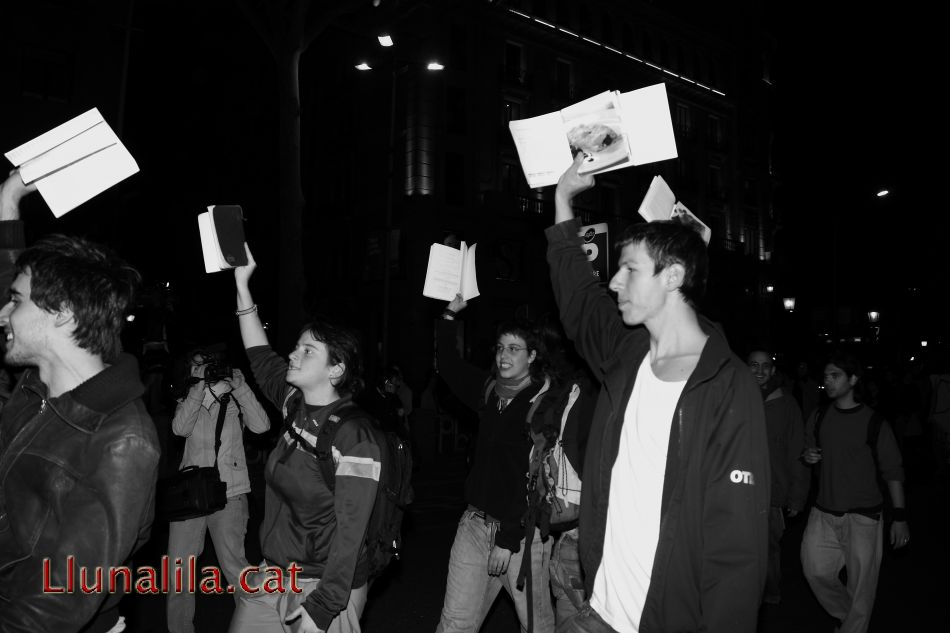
[0,354,160,633]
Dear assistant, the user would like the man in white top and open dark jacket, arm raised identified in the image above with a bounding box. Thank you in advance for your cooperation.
[547,154,769,633]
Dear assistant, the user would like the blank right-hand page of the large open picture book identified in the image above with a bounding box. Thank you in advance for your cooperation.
[620,84,677,165]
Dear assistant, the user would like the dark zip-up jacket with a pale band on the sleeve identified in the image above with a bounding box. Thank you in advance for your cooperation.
[247,345,380,631]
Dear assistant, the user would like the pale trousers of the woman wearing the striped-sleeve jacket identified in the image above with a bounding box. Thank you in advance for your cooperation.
[228,572,369,633]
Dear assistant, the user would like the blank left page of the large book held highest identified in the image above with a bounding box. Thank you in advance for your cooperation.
[508,112,574,189]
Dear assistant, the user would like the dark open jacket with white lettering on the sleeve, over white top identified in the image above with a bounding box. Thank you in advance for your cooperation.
[546,220,770,633]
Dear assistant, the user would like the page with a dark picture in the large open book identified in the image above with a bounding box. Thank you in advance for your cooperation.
[561,91,630,174]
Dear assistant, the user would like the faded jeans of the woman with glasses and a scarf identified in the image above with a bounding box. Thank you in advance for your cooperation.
[436,510,554,633]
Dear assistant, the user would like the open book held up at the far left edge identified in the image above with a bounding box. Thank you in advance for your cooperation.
[5,108,139,218]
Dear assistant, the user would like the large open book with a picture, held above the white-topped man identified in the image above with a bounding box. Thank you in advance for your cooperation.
[508,84,677,189]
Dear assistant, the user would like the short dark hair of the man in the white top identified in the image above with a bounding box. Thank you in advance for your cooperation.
[614,220,709,307]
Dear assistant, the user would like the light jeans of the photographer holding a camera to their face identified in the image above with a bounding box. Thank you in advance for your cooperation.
[166,494,248,633]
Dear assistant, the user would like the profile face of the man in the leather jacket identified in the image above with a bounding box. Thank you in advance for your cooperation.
[0,269,56,367]
